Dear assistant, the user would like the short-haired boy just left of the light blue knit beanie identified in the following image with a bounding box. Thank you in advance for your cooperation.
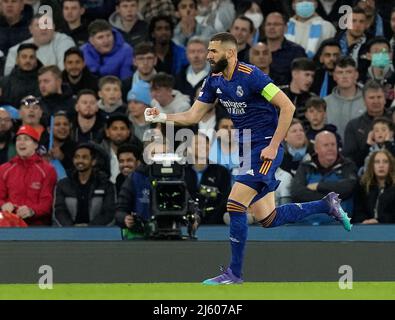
[98,76,126,120]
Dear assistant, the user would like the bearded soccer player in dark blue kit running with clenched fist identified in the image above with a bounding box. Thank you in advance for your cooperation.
[145,33,351,285]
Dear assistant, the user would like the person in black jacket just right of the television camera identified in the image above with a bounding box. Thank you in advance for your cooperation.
[185,132,231,224]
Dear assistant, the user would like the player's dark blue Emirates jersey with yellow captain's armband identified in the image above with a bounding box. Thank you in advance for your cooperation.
[198,62,280,148]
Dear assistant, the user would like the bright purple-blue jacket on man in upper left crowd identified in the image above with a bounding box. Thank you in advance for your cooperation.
[81,29,133,80]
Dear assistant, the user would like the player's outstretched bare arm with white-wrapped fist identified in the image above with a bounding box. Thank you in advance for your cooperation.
[144,100,213,126]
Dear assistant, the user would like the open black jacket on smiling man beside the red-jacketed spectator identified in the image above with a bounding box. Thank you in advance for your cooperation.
[54,172,116,226]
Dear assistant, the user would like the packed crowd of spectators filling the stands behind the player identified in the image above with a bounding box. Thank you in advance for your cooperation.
[0,0,395,228]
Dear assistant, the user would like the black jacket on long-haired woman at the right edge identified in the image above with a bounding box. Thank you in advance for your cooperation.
[352,185,395,223]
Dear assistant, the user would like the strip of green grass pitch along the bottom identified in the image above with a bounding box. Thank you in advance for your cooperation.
[0,282,395,300]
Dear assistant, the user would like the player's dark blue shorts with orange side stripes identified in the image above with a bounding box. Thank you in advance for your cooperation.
[235,146,284,204]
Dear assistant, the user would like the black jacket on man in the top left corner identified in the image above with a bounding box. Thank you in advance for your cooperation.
[0,5,33,56]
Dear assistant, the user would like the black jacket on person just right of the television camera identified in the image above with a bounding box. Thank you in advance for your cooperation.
[185,164,231,224]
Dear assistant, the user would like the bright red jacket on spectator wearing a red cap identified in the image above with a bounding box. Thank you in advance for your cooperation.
[0,154,56,225]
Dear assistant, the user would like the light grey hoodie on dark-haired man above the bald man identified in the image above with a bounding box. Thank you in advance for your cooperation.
[324,87,366,141]
